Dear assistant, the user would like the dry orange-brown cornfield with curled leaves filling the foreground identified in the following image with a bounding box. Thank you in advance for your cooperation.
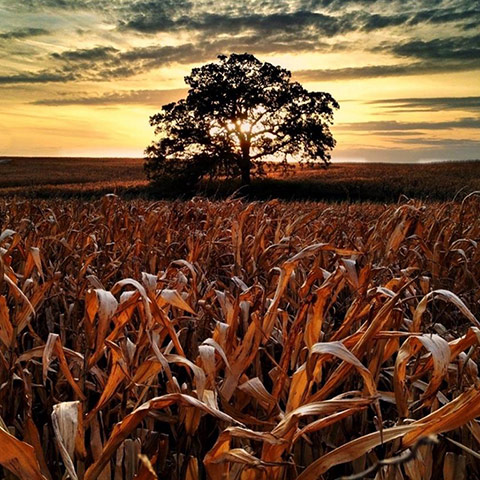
[0,195,480,480]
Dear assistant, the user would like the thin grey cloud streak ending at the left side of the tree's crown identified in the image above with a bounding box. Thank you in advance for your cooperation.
[32,89,187,107]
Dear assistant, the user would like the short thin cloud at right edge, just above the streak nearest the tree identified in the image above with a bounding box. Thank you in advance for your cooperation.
[368,97,480,112]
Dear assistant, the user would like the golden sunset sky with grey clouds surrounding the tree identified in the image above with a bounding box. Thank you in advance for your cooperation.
[0,0,480,162]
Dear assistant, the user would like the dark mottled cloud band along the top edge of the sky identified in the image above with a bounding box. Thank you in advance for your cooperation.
[118,0,480,39]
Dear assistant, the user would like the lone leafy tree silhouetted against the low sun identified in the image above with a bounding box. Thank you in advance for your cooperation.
[145,53,339,185]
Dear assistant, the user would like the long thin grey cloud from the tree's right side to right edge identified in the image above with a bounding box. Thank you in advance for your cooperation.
[335,118,480,132]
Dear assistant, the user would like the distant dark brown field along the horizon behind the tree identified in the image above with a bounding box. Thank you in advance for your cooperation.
[0,158,480,201]
